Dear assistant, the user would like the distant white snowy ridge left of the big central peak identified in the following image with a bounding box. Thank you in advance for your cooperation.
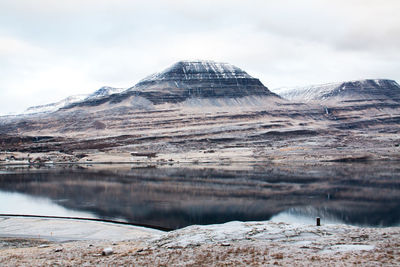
[23,86,126,114]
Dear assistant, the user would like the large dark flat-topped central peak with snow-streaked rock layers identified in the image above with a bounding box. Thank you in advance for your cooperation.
[66,61,279,107]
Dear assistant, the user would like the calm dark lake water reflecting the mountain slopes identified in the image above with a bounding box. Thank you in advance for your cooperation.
[0,162,400,229]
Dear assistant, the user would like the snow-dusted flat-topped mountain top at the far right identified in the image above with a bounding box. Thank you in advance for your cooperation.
[276,79,400,102]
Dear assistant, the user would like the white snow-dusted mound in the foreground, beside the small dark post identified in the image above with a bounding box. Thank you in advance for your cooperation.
[149,221,382,252]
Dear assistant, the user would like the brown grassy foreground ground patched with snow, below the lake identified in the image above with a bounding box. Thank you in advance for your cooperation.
[0,219,400,266]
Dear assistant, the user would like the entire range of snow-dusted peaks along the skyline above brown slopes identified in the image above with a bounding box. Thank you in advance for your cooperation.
[16,63,400,114]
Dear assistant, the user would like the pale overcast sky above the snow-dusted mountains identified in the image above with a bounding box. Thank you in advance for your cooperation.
[0,0,400,114]
